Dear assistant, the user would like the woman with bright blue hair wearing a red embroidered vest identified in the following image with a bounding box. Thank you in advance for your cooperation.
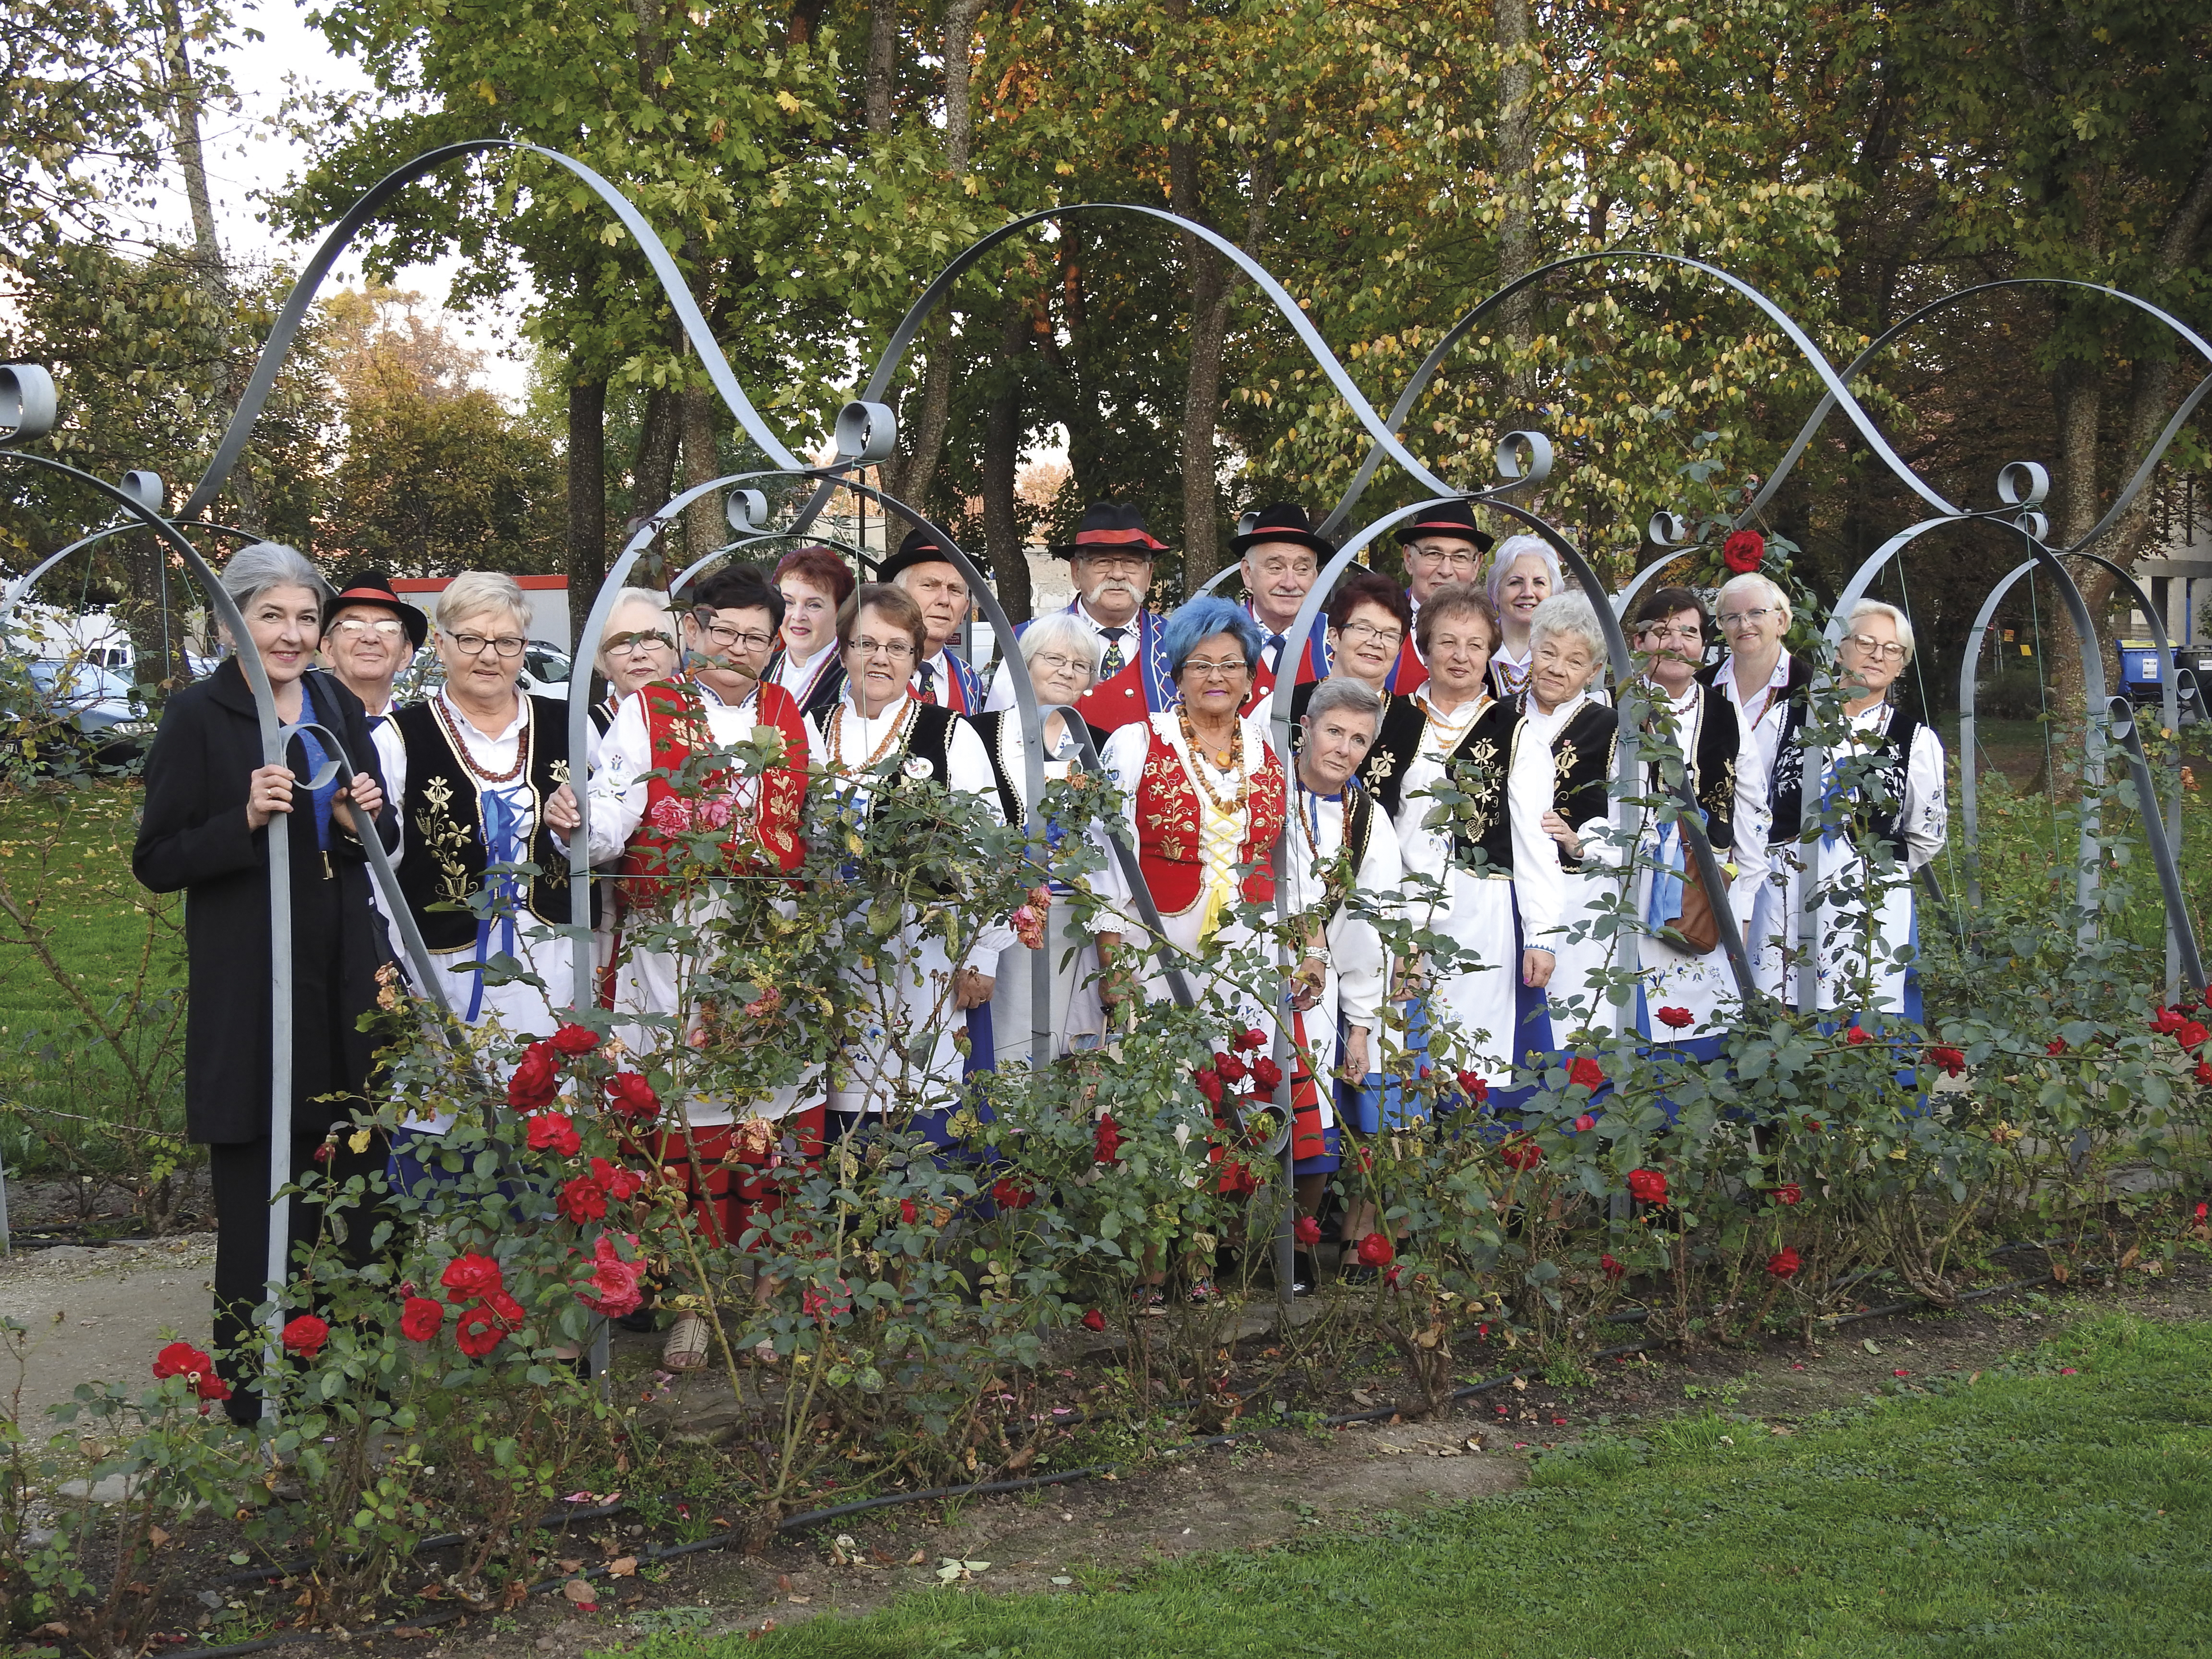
[1099,595,1285,1301]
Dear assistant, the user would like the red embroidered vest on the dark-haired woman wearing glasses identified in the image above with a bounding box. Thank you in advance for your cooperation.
[619,681,807,905]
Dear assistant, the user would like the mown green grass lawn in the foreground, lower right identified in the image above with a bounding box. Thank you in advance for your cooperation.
[694,1314,2212,1659]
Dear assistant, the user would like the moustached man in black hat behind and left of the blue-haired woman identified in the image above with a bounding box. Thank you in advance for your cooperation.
[989,502,1175,745]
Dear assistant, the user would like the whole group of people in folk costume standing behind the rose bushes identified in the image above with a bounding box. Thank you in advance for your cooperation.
[135,502,1944,1414]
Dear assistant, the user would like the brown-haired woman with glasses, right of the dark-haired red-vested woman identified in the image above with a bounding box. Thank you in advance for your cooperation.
[814,582,1013,1143]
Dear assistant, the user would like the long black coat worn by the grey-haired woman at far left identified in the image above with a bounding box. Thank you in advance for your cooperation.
[131,659,398,1146]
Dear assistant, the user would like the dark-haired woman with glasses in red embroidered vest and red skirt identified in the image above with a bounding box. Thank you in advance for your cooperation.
[590,564,825,1369]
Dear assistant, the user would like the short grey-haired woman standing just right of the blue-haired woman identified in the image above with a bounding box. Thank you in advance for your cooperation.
[1283,674,1405,1294]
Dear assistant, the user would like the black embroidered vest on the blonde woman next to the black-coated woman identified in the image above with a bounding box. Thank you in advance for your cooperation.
[392,697,600,951]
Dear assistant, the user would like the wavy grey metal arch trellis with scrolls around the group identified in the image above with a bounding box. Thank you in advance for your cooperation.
[13,139,2212,1318]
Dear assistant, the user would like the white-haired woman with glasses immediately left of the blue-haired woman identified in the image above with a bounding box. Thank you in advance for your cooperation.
[974,611,1128,1066]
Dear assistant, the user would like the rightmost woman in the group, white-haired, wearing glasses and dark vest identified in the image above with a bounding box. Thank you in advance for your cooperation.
[1774,600,1947,1020]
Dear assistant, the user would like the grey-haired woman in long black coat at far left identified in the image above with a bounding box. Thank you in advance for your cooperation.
[131,542,398,1422]
